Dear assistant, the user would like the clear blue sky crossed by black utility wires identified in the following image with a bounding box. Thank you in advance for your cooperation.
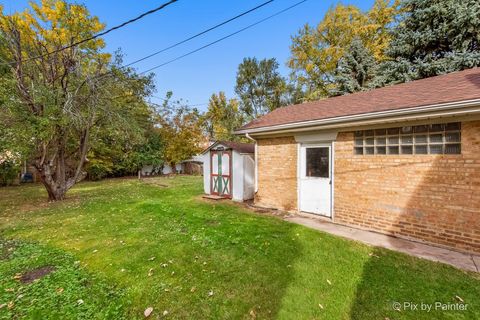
[0,0,374,110]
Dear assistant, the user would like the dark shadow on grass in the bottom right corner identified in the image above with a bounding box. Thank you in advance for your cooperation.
[350,248,480,320]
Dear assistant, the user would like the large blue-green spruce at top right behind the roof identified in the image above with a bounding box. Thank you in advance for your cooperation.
[378,0,480,85]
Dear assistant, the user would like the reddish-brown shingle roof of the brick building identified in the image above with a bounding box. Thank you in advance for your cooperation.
[239,68,480,130]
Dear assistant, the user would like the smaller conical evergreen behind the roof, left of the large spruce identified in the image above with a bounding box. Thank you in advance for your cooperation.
[331,38,377,95]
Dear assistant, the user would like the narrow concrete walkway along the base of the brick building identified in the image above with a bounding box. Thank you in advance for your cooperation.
[284,215,480,272]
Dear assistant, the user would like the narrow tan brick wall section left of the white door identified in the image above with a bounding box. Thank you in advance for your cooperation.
[255,137,297,211]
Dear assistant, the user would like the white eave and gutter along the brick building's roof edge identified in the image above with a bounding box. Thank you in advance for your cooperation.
[235,99,480,135]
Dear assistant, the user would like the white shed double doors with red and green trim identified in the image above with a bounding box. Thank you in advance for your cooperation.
[210,150,232,198]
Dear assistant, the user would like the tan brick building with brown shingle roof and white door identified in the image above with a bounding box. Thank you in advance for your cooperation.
[237,68,480,253]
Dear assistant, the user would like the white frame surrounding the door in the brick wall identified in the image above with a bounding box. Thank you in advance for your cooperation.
[297,141,335,221]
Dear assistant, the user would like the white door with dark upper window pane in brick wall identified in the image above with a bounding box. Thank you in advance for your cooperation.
[299,144,332,217]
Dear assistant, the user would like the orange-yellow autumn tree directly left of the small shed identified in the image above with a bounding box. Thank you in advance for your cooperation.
[155,92,205,172]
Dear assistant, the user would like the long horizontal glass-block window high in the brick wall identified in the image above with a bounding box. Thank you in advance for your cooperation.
[354,122,462,155]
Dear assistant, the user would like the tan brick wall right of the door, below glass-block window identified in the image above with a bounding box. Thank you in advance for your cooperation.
[334,121,480,252]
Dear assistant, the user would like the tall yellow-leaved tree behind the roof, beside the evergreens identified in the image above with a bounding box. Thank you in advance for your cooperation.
[288,0,398,100]
